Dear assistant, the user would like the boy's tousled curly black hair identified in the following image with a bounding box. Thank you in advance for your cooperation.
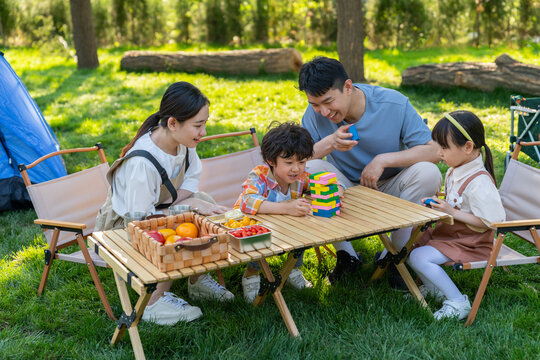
[261,122,315,163]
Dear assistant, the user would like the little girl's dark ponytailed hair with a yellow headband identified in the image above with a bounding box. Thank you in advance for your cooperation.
[431,110,497,185]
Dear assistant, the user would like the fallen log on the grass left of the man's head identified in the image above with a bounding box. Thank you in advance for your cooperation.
[120,48,302,74]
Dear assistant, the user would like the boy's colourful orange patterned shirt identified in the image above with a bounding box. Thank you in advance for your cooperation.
[234,165,309,215]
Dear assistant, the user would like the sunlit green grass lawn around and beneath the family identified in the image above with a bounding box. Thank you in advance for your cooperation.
[0,47,540,359]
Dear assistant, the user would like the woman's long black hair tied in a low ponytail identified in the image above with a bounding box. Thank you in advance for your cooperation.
[120,81,210,157]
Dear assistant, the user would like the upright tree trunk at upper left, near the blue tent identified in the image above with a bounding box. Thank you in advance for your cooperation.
[69,0,99,69]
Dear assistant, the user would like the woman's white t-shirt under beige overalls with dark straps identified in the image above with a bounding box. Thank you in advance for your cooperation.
[111,133,202,216]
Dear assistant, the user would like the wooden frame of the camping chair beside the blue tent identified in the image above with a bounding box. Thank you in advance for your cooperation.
[18,143,116,321]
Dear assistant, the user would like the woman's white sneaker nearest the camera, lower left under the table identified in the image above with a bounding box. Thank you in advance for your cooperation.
[142,291,202,325]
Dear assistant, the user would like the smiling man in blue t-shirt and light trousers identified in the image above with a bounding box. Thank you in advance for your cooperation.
[298,57,442,288]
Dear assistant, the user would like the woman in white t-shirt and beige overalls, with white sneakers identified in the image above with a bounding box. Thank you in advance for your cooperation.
[96,82,234,325]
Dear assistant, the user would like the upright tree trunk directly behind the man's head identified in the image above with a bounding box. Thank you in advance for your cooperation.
[337,0,366,82]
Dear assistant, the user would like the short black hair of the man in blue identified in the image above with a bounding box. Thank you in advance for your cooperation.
[298,56,349,96]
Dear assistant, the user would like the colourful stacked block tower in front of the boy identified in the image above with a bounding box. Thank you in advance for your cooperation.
[309,172,341,217]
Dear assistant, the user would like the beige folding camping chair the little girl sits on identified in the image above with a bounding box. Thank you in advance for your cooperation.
[445,141,540,326]
